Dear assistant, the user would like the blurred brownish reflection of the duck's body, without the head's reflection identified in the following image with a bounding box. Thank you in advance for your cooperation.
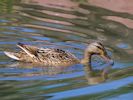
[7,62,66,76]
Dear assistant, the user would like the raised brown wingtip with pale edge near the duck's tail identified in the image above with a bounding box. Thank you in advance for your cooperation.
[17,43,38,58]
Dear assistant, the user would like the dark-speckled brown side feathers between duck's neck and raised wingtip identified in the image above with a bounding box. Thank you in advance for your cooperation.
[37,48,79,64]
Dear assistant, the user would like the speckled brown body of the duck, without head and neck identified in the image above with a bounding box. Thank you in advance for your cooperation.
[5,43,80,66]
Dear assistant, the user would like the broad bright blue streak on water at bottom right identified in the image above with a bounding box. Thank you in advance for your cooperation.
[48,76,133,100]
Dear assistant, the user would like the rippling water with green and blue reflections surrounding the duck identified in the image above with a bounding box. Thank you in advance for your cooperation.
[0,0,133,100]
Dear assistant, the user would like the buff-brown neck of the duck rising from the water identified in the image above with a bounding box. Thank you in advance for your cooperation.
[82,51,92,71]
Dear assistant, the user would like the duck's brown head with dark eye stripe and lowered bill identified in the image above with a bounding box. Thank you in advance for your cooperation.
[86,42,114,65]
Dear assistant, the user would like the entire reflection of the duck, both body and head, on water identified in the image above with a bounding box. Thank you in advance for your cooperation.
[8,62,116,85]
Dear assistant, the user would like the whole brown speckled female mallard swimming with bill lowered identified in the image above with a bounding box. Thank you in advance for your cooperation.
[4,42,110,69]
